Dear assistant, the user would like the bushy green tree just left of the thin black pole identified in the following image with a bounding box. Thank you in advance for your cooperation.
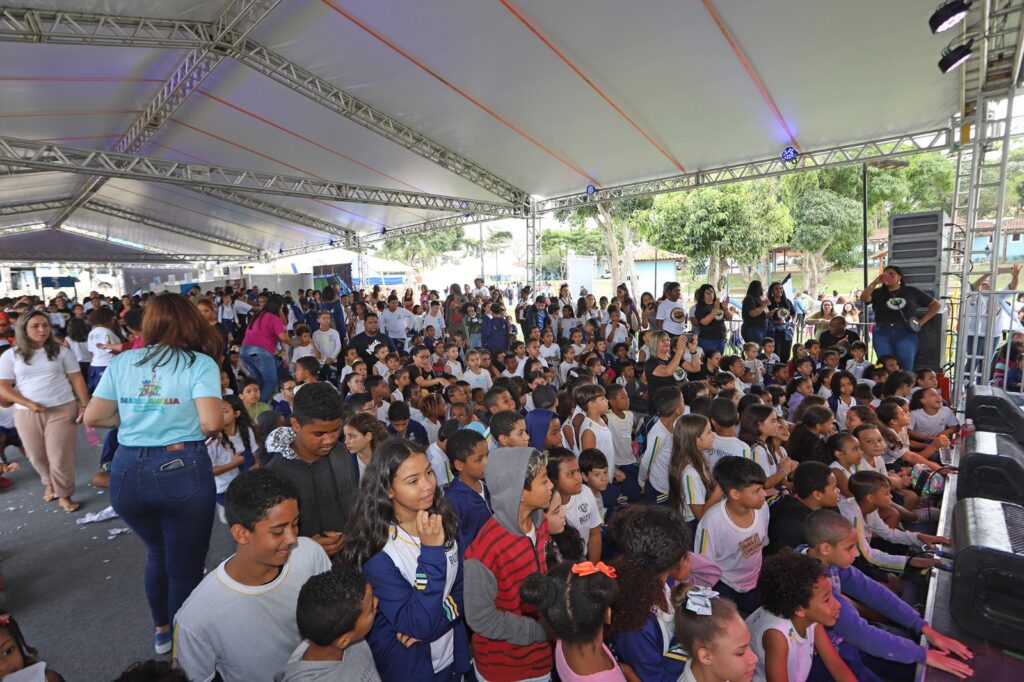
[793,189,862,296]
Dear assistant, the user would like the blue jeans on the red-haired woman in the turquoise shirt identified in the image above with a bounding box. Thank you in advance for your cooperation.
[111,441,216,627]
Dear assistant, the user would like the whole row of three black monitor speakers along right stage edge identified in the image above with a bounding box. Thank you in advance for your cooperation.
[949,386,1024,651]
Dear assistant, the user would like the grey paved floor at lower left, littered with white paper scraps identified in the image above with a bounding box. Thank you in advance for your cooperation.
[0,427,233,682]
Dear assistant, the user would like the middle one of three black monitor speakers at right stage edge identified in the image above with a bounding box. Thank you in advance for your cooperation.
[956,431,1024,505]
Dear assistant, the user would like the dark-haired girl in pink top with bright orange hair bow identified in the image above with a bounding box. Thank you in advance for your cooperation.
[520,561,626,682]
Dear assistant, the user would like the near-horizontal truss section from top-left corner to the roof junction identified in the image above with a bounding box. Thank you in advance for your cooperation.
[0,7,214,48]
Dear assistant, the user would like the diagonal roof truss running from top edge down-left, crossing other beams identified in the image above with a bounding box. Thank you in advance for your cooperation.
[49,0,280,227]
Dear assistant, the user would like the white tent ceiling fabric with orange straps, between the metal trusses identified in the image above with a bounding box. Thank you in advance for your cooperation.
[0,0,959,259]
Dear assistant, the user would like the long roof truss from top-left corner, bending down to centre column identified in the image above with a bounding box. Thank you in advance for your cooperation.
[0,0,529,205]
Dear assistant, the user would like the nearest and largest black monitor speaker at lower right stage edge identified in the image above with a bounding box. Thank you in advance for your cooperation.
[949,497,1024,651]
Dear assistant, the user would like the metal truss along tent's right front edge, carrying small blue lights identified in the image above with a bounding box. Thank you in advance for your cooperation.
[534,128,952,213]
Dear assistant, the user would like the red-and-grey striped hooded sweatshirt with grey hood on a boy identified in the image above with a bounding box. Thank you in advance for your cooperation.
[465,447,554,682]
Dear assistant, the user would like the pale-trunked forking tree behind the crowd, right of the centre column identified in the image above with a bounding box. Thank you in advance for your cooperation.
[555,197,653,291]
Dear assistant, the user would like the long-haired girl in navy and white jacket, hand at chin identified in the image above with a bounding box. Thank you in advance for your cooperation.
[342,438,470,682]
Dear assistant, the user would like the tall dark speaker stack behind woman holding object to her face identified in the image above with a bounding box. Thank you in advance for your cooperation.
[888,211,949,370]
